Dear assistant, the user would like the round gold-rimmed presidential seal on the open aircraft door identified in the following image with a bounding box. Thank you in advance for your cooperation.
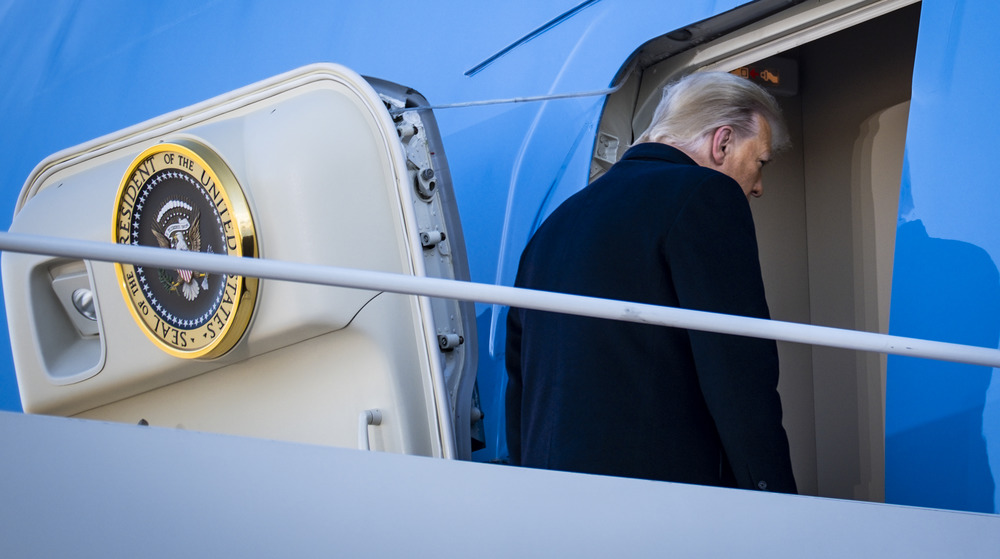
[114,140,258,359]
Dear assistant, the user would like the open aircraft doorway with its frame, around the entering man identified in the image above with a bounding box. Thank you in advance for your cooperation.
[591,0,920,501]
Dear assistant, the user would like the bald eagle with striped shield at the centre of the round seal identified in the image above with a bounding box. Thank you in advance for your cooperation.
[152,200,208,301]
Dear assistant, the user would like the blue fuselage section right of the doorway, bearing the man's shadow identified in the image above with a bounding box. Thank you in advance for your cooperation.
[885,0,1000,512]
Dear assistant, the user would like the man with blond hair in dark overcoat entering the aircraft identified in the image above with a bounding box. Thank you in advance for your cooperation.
[506,72,796,493]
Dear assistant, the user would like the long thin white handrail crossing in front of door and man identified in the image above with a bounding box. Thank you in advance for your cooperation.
[0,232,1000,367]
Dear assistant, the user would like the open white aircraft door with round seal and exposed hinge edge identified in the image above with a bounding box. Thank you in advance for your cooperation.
[3,64,478,458]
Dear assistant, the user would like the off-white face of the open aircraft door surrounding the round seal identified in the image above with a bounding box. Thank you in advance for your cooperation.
[3,64,452,455]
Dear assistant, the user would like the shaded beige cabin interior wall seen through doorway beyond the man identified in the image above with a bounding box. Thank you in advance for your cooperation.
[751,6,919,501]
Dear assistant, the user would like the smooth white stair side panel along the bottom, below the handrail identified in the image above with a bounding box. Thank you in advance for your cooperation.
[0,413,1000,559]
